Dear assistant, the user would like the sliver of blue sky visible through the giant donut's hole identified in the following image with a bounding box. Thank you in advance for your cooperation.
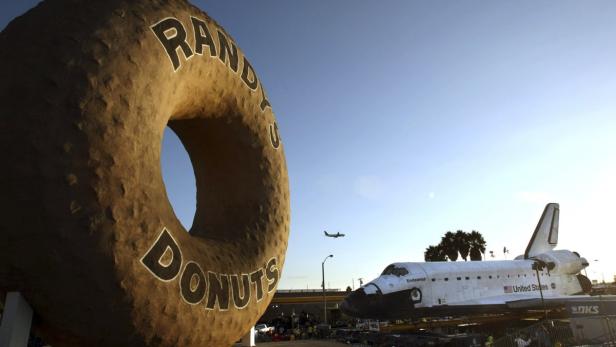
[160,126,197,230]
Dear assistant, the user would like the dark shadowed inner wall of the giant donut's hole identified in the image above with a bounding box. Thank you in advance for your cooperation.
[168,115,275,241]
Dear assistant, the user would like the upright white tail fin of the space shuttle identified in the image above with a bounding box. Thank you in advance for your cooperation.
[524,202,560,259]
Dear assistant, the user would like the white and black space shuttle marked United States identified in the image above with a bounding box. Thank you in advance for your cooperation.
[340,203,614,319]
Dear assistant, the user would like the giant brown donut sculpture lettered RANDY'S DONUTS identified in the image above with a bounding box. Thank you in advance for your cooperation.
[0,0,290,347]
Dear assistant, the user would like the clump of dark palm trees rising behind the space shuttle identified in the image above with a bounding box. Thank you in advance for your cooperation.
[424,230,486,261]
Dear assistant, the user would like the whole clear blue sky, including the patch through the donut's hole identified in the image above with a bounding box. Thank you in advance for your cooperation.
[0,0,616,289]
